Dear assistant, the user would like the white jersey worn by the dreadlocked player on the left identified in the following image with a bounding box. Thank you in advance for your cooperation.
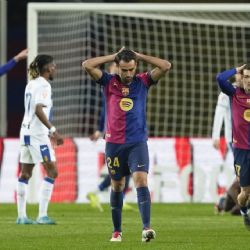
[20,77,52,138]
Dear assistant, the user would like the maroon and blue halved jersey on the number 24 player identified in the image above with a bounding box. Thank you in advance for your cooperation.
[97,71,156,144]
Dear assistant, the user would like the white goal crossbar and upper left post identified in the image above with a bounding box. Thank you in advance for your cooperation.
[27,3,250,64]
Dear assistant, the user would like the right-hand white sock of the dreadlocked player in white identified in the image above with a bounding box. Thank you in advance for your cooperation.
[38,177,54,217]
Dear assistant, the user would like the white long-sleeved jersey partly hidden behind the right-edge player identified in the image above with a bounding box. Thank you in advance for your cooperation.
[212,92,232,143]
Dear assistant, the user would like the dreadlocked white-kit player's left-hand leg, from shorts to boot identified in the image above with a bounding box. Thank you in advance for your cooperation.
[16,146,34,224]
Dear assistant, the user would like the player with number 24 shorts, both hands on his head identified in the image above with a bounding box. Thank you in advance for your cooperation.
[83,48,171,242]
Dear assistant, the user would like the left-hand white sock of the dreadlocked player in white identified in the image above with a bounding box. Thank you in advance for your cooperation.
[17,180,28,218]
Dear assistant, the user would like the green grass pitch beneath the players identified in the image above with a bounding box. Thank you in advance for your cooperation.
[0,203,250,250]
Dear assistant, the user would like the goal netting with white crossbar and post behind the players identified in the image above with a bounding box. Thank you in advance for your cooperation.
[28,3,250,137]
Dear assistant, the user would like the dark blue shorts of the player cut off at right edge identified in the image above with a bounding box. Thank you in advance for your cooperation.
[233,148,250,187]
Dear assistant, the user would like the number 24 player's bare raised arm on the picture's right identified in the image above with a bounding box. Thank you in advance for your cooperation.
[135,52,171,81]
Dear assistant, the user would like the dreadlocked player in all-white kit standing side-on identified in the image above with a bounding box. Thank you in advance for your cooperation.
[16,55,63,224]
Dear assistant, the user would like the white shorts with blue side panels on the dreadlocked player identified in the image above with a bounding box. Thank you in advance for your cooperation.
[20,136,56,164]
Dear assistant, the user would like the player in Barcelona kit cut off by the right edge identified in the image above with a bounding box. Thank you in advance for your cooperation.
[217,64,250,230]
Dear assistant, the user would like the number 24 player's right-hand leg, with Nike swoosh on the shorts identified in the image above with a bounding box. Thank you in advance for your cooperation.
[129,142,155,242]
